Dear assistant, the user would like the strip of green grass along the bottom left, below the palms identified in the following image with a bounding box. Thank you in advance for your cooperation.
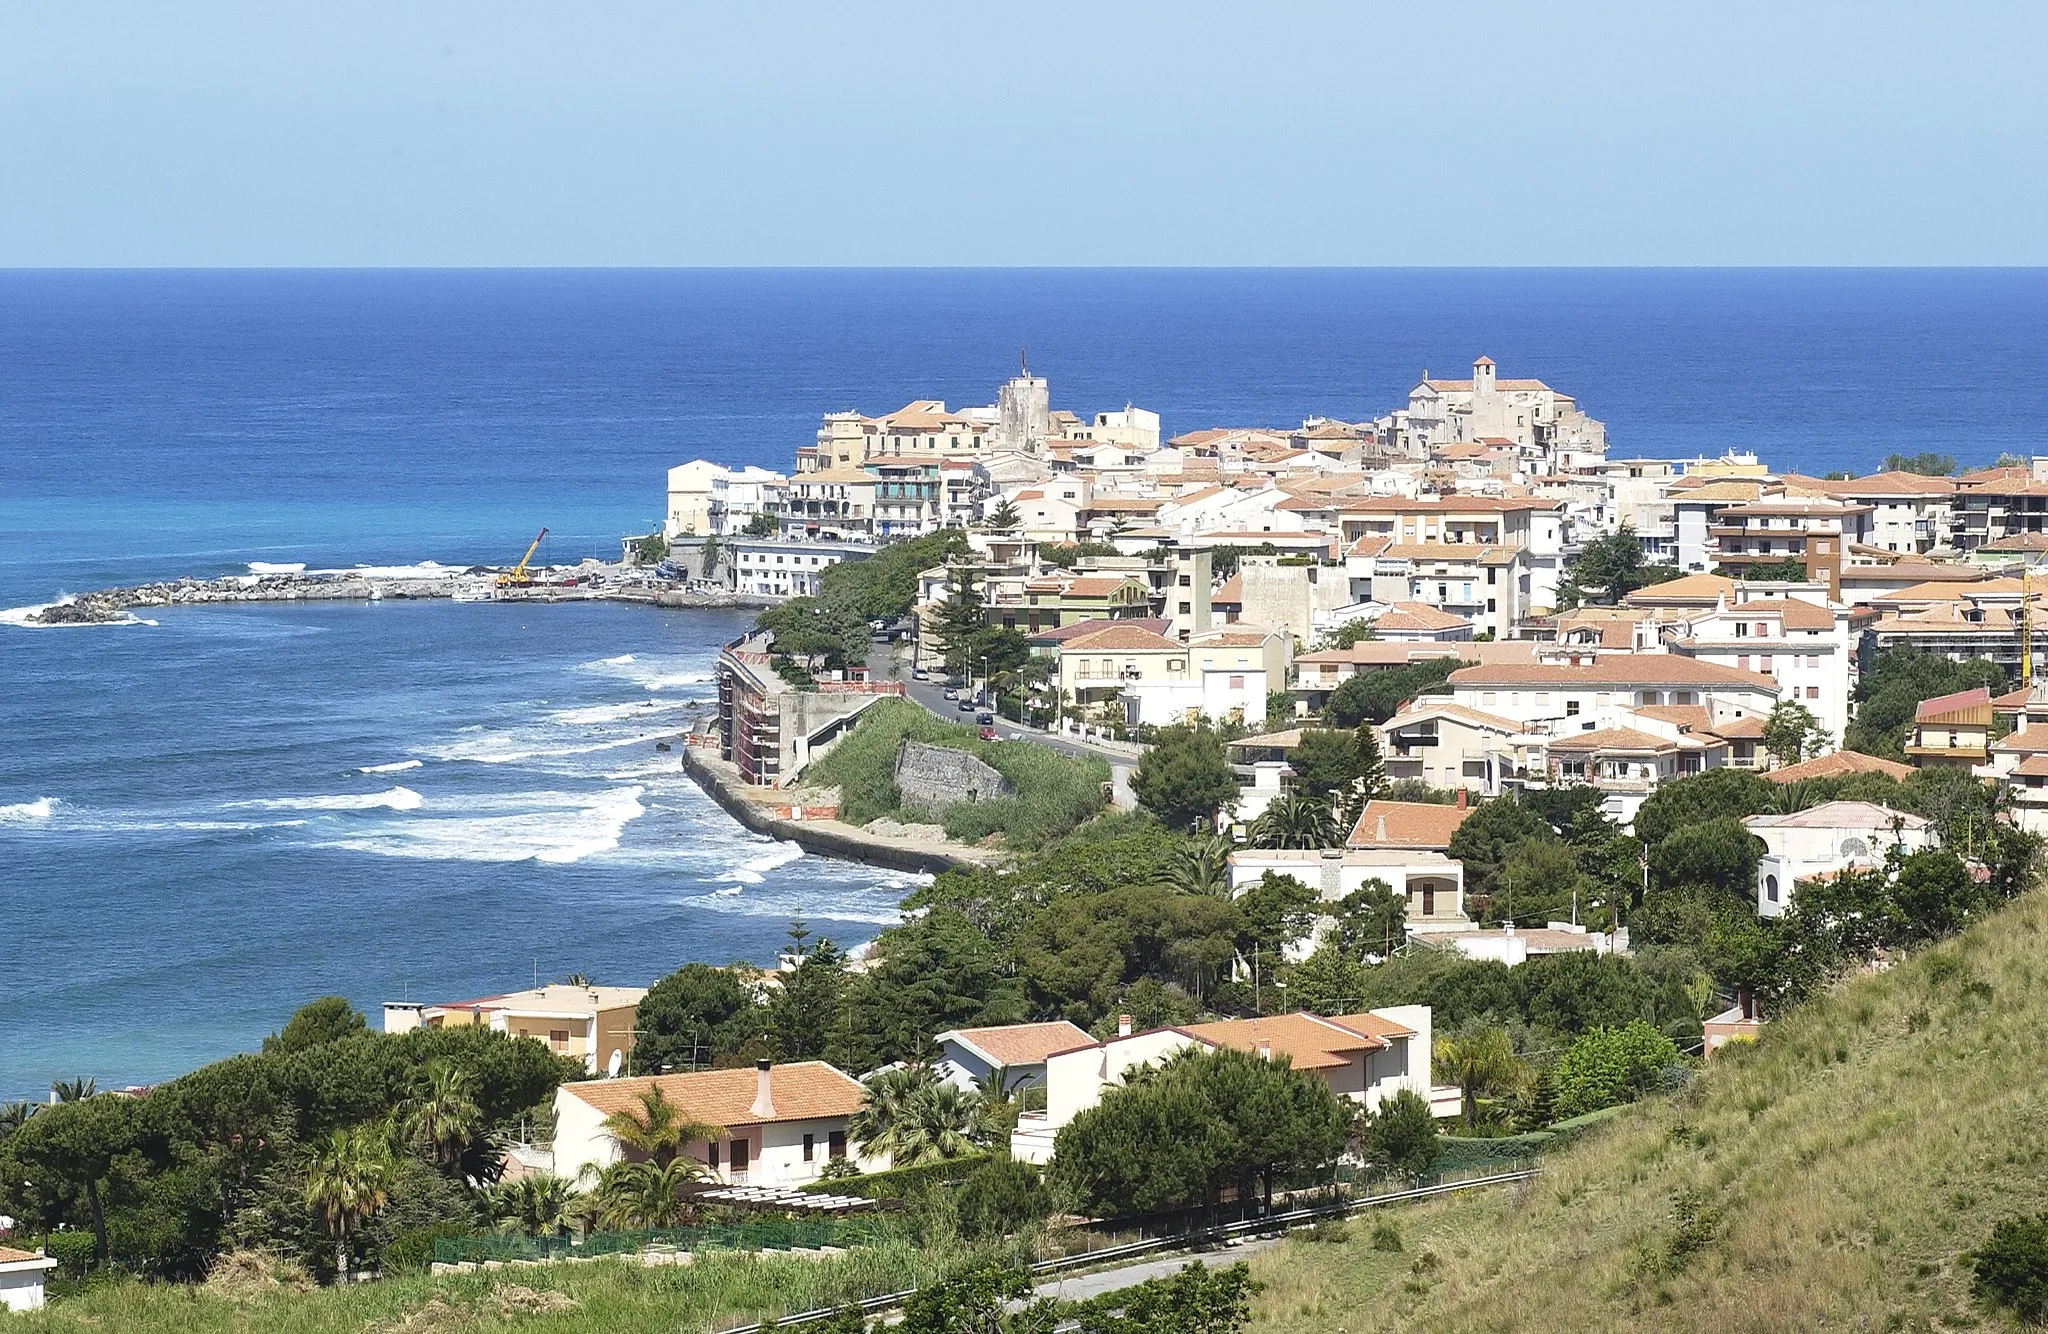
[14,1242,928,1334]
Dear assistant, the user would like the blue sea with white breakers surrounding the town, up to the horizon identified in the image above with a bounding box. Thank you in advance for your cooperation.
[0,270,2048,1098]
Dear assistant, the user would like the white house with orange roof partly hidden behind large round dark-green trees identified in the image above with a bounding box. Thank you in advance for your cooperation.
[1010,1006,1442,1164]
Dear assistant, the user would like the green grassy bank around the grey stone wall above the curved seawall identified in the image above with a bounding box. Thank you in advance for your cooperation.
[805,699,1110,848]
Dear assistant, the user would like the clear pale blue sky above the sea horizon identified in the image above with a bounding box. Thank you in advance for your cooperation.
[0,0,2048,266]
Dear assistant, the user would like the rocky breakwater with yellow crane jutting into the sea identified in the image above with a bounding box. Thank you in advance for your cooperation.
[25,568,772,625]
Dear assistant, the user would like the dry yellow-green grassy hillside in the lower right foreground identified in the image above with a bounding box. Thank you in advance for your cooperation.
[1236,891,2048,1334]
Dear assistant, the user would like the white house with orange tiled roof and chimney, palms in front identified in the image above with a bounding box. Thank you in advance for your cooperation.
[555,1061,889,1186]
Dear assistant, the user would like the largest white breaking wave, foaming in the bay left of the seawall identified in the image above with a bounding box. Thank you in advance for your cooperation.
[317,787,647,865]
